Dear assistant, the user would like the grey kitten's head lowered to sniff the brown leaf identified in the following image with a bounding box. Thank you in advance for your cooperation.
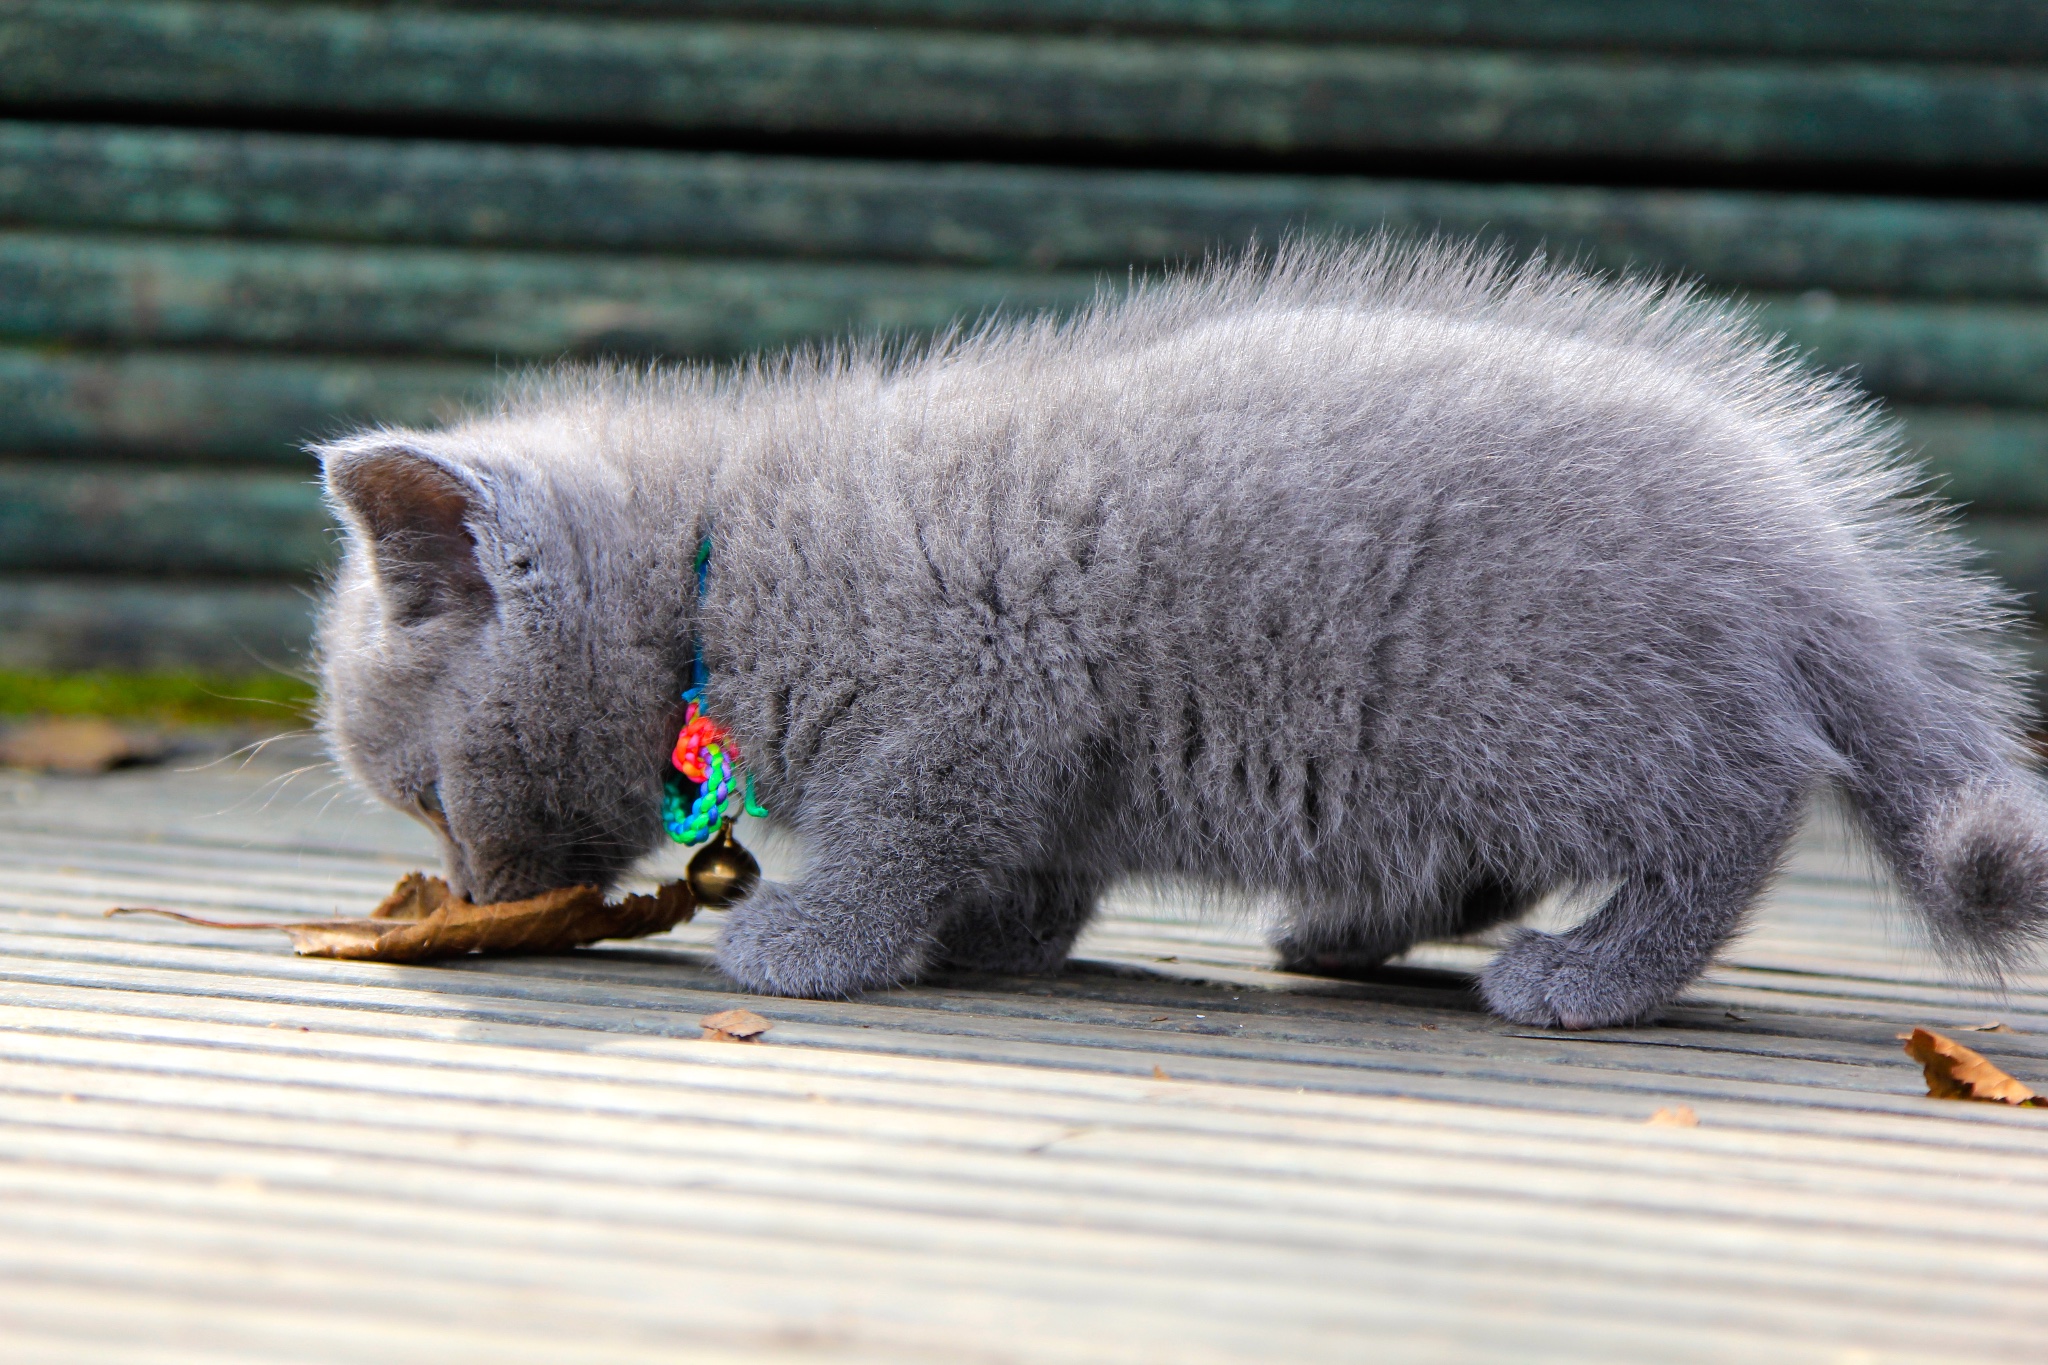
[319,432,688,902]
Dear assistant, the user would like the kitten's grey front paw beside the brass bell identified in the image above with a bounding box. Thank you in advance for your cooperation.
[719,884,922,1001]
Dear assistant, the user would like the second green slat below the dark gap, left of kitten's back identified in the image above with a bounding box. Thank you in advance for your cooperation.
[0,233,1096,358]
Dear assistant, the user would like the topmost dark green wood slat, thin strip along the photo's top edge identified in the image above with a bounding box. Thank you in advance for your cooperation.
[495,0,2048,61]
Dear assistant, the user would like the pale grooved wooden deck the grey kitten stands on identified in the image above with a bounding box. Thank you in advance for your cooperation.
[0,740,2048,1365]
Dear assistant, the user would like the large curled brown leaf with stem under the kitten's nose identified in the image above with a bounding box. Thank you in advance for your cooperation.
[106,872,696,962]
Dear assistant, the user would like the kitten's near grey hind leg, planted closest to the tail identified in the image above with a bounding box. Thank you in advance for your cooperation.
[1479,798,1798,1029]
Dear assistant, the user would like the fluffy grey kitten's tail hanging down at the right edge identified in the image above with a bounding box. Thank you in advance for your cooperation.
[1825,634,2048,980]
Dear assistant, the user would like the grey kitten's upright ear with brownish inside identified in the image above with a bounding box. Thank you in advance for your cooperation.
[319,440,494,626]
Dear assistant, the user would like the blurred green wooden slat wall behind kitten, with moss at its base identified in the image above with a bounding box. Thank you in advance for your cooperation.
[0,0,2048,718]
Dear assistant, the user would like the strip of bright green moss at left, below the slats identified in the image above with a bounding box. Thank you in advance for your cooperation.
[0,669,313,724]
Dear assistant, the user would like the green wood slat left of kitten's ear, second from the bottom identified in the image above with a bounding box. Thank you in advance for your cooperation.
[0,460,334,577]
